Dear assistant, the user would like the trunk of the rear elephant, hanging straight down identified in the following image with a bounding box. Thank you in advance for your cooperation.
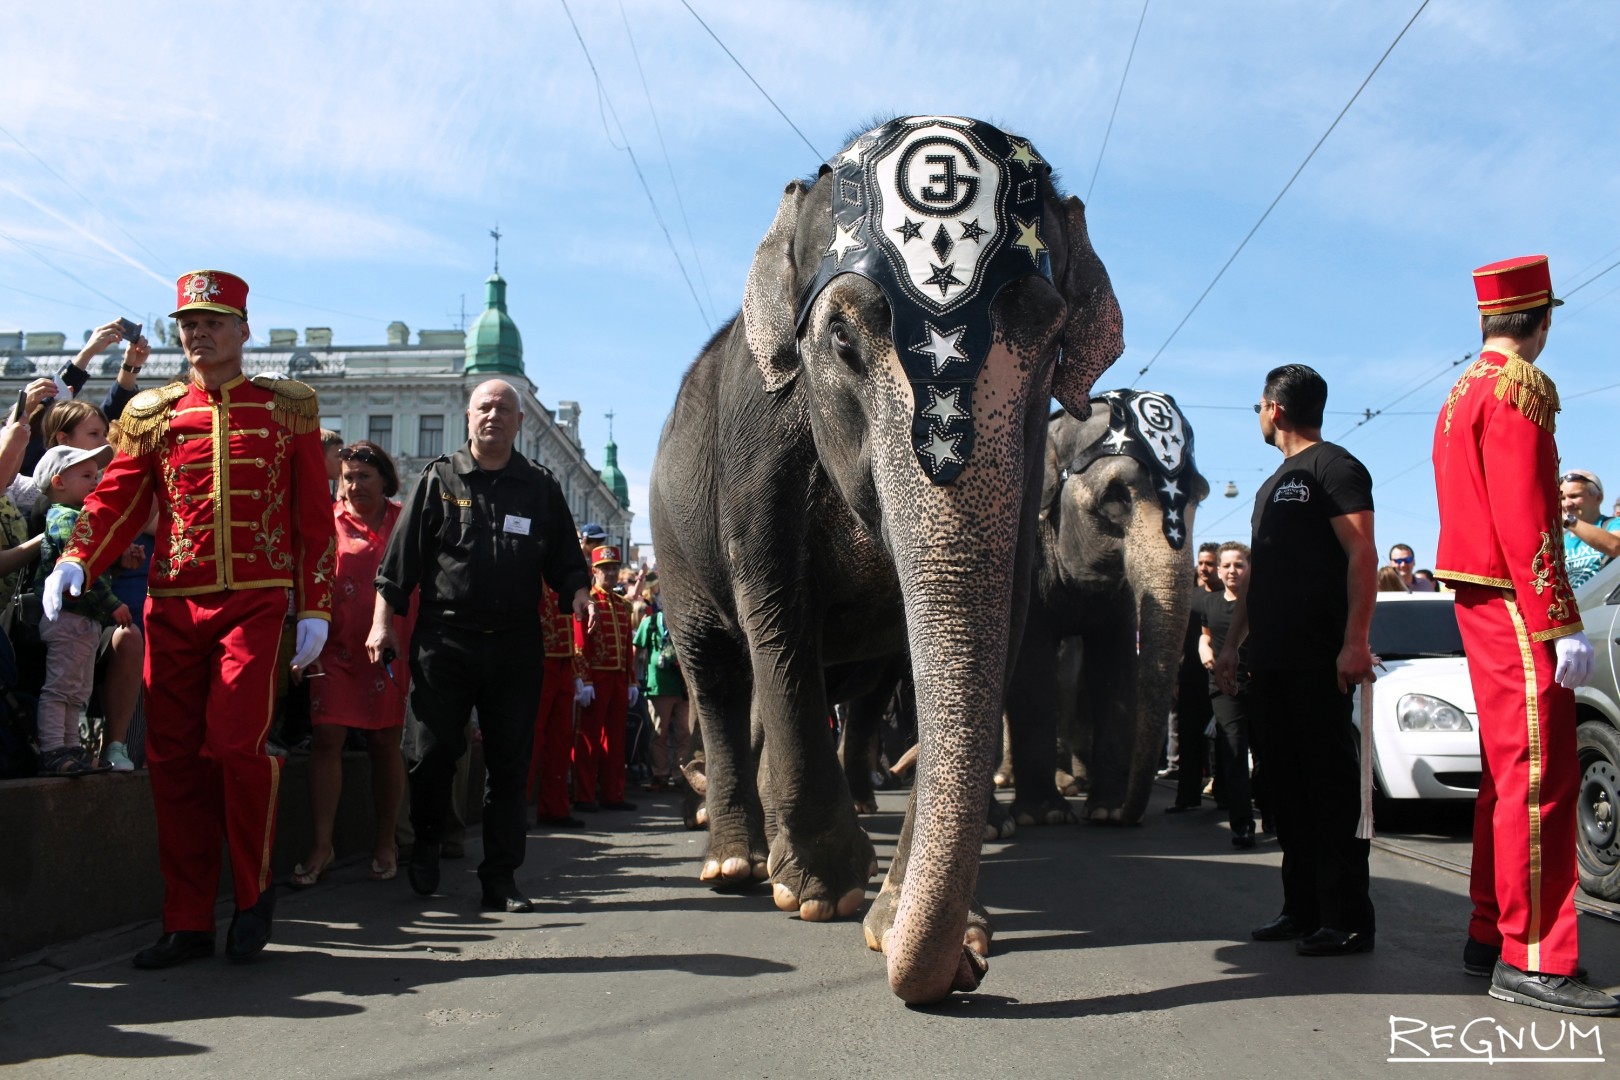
[1121,497,1192,823]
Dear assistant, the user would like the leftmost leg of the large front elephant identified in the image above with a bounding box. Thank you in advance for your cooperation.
[689,669,770,887]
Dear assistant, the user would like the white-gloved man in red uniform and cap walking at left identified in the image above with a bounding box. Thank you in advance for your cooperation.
[42,270,334,968]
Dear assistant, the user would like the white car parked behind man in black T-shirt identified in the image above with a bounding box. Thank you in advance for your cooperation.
[1354,593,1481,800]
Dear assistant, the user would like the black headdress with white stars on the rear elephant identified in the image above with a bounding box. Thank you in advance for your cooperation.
[1063,390,1197,551]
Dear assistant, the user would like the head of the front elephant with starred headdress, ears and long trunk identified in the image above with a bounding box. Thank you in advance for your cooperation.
[742,117,1123,1001]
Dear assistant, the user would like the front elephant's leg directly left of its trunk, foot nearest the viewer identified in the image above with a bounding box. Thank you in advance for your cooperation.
[751,637,878,923]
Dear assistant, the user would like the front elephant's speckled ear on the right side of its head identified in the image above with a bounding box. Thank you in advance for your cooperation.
[1051,196,1124,419]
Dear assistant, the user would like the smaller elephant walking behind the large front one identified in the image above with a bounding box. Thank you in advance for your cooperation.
[1008,390,1209,824]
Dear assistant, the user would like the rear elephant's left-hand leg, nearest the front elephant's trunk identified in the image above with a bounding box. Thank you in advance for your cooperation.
[1006,617,1074,826]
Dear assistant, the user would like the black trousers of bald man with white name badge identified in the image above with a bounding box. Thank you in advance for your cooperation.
[410,622,546,884]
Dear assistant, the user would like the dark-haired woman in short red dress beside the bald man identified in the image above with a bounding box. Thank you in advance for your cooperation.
[293,439,415,889]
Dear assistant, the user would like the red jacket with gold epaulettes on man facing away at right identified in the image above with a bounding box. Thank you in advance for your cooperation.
[1434,351,1581,641]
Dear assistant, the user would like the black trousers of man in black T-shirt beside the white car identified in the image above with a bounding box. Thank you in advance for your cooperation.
[1247,667,1375,934]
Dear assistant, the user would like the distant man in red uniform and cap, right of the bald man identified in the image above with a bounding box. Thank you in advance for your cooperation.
[573,546,635,811]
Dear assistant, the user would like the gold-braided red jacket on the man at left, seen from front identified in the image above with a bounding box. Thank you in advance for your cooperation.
[63,376,335,619]
